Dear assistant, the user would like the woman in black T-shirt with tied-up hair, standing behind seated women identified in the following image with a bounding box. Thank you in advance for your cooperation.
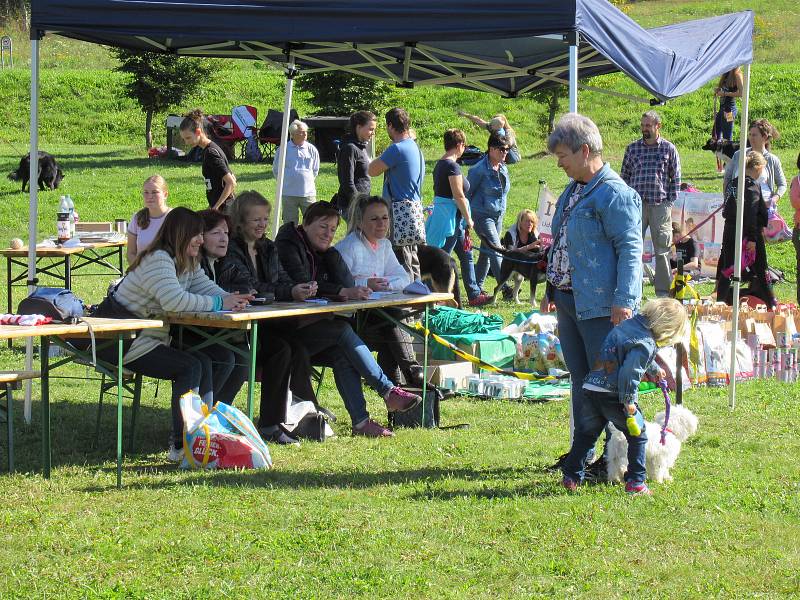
[179,108,236,212]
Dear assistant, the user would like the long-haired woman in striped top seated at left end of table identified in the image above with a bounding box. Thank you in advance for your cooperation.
[98,207,253,461]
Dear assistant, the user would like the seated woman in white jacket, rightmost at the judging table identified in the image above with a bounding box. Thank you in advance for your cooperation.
[336,195,422,386]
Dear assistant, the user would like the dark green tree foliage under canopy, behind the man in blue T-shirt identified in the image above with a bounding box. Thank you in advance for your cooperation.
[297,71,392,117]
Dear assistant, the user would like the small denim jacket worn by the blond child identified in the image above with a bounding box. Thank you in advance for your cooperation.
[583,315,658,404]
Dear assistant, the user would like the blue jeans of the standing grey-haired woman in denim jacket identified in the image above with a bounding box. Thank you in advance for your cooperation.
[552,289,614,446]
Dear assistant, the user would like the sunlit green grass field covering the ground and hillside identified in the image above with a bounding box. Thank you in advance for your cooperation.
[0,0,800,599]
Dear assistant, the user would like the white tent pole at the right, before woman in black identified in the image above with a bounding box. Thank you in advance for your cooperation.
[728,63,750,410]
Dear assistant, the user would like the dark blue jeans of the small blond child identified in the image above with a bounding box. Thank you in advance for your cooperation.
[562,390,647,485]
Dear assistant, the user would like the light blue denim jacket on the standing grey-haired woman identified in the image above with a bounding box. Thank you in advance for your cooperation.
[552,163,642,320]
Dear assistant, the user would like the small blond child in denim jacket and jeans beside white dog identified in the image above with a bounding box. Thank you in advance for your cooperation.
[562,298,688,495]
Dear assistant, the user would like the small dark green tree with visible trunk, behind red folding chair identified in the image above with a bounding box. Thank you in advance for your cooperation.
[111,48,213,150]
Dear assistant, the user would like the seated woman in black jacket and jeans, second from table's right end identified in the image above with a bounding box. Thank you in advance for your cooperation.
[275,202,420,437]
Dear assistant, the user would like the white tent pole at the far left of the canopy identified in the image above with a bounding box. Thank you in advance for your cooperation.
[23,32,39,425]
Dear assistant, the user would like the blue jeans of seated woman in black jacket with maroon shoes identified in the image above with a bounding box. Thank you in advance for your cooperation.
[293,318,394,425]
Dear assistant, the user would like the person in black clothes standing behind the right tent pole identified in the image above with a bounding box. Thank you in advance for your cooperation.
[717,150,775,308]
